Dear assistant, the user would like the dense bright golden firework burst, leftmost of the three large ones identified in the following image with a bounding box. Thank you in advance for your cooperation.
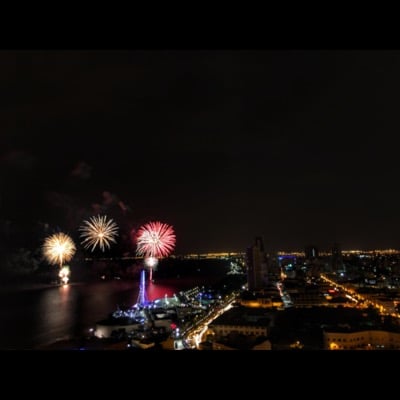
[42,232,76,267]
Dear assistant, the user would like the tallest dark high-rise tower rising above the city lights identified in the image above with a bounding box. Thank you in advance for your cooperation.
[246,236,267,290]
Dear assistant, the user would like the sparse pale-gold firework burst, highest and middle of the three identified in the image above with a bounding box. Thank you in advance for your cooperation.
[79,215,118,252]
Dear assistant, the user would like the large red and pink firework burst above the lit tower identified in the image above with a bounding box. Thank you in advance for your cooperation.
[136,221,176,258]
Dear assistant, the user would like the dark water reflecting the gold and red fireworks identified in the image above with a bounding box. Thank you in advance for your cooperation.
[0,279,209,350]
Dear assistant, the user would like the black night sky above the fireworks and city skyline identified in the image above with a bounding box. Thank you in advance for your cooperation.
[0,50,400,254]
